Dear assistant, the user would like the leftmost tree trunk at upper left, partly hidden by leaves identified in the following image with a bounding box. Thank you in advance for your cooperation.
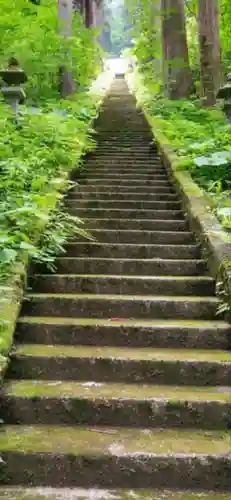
[58,0,75,97]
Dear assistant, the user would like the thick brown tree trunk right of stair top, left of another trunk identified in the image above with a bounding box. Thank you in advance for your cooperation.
[162,0,194,99]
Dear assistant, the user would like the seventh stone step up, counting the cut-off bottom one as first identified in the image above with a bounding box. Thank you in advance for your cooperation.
[30,274,215,296]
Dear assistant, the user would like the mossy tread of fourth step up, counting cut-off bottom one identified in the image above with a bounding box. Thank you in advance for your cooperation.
[16,344,231,363]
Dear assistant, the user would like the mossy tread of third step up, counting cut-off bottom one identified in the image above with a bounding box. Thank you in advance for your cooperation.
[5,380,231,402]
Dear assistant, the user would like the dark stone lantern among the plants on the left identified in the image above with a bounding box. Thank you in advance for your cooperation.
[0,57,27,113]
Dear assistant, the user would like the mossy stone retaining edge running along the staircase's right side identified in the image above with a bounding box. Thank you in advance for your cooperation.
[143,110,231,314]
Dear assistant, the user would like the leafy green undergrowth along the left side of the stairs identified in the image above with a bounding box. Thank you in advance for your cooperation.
[0,95,96,281]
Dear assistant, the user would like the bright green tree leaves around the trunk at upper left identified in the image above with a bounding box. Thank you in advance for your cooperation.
[0,0,100,103]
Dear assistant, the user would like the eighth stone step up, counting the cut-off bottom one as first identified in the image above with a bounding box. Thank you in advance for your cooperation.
[53,257,207,276]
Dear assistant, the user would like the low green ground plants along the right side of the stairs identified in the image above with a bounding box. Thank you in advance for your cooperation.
[140,88,231,229]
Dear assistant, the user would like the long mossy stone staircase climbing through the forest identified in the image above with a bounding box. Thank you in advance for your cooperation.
[0,78,231,500]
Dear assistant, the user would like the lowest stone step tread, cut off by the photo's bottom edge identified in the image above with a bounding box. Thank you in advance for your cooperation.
[0,487,230,500]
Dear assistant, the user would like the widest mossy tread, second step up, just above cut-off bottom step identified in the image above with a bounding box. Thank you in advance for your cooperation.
[0,425,231,456]
